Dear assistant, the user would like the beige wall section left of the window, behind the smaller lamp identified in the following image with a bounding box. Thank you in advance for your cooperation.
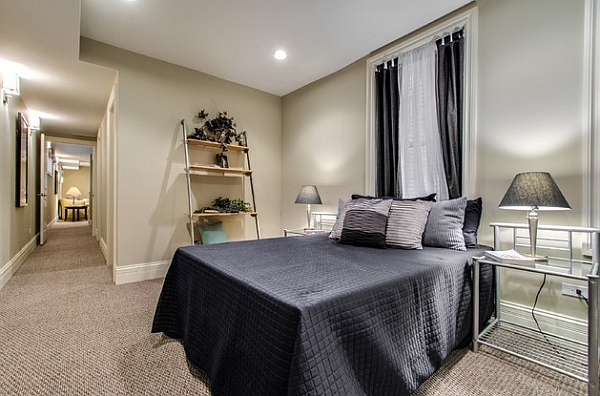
[281,59,366,228]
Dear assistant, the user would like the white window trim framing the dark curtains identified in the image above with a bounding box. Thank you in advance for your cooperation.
[365,7,479,196]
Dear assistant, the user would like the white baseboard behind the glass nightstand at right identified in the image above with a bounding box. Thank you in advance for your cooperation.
[500,301,587,342]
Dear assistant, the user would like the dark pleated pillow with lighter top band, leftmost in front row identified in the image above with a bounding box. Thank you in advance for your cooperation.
[340,199,392,248]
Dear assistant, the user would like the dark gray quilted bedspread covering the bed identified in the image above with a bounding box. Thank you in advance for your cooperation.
[152,235,491,396]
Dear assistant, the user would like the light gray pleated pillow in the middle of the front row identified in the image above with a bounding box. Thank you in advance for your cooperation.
[385,201,433,249]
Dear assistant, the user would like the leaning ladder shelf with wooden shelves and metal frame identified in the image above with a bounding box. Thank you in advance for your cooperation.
[181,119,260,245]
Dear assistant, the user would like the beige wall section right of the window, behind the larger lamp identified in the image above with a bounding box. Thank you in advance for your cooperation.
[476,0,588,318]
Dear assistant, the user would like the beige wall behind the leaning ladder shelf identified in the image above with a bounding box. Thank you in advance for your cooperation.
[81,39,282,266]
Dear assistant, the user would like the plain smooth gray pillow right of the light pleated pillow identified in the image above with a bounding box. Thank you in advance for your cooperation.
[423,197,467,250]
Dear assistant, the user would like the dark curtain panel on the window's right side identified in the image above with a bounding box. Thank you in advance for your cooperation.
[436,30,464,199]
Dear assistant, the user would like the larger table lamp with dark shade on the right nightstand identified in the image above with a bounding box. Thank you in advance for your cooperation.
[498,172,571,261]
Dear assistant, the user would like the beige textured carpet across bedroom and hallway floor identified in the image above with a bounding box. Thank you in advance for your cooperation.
[0,222,587,396]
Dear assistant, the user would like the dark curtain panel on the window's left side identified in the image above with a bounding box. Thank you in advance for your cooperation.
[375,58,402,197]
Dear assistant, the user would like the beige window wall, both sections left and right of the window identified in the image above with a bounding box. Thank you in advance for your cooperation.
[282,0,588,316]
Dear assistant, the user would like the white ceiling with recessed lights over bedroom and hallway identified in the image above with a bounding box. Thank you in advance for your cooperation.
[0,0,470,158]
